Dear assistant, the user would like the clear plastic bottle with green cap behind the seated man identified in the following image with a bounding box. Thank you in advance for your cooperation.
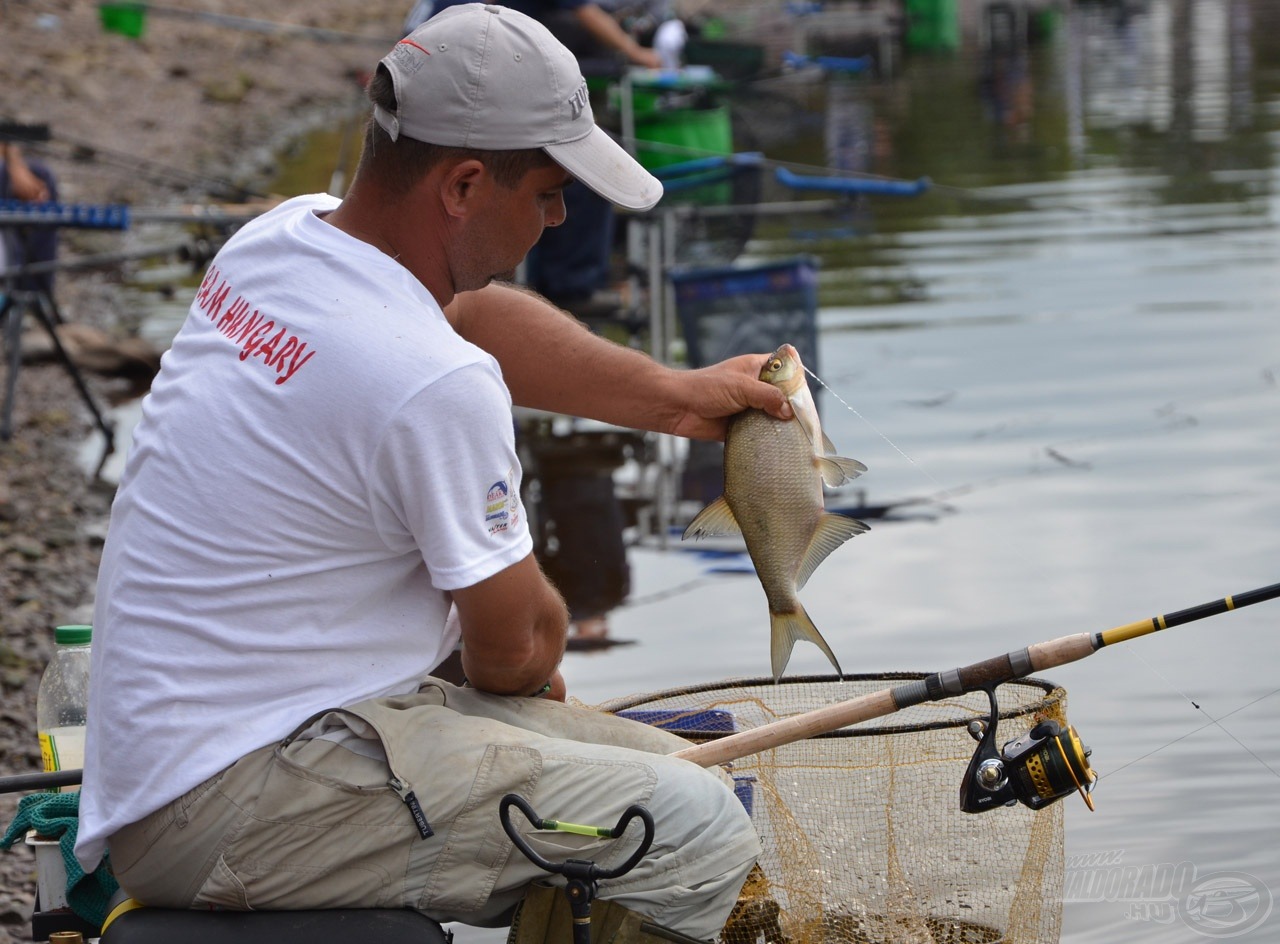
[36,625,93,792]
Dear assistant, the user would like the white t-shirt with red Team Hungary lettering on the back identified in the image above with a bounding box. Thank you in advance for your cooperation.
[76,194,532,869]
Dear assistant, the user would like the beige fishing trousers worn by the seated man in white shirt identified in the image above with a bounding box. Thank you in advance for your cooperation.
[108,679,760,939]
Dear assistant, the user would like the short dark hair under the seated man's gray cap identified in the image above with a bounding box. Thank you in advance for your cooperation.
[360,63,556,193]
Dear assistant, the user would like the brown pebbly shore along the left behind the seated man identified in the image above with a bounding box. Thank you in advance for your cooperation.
[0,0,411,944]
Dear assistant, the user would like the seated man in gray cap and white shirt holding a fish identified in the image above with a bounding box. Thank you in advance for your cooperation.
[77,4,790,944]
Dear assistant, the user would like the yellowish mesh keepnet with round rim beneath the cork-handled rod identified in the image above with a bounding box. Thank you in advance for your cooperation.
[600,673,1066,944]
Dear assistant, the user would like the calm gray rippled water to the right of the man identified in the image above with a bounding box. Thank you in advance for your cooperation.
[92,0,1280,944]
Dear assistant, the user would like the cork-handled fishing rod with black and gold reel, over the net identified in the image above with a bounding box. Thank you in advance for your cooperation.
[673,583,1280,812]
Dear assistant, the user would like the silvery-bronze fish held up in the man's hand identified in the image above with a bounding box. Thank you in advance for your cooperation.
[684,344,869,680]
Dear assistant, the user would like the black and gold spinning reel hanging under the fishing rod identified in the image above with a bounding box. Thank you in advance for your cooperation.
[960,686,1097,812]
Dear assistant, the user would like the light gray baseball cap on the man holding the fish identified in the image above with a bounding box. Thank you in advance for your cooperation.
[374,4,662,210]
